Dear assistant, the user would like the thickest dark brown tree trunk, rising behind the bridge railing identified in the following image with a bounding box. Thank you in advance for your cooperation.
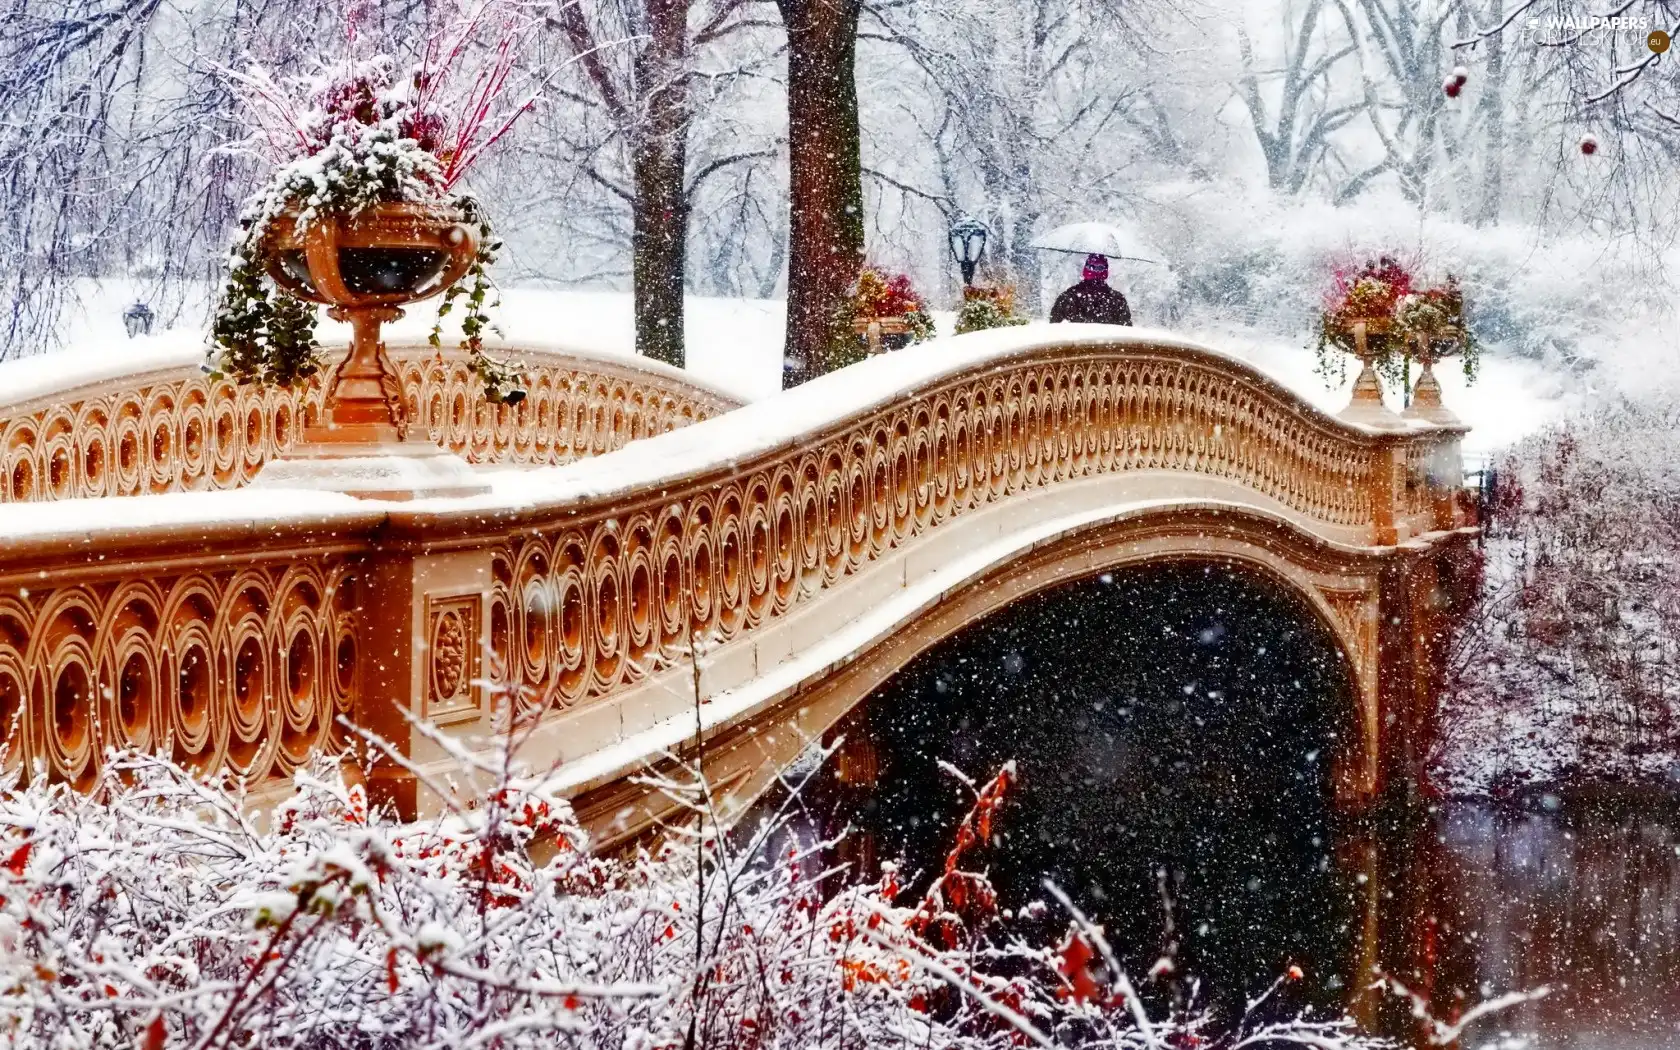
[776,0,864,386]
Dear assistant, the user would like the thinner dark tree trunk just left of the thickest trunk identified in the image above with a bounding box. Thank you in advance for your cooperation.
[630,0,689,368]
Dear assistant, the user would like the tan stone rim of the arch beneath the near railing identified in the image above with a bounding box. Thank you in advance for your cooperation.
[575,502,1413,842]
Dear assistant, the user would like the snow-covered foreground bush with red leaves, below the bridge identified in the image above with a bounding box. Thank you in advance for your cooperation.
[0,732,1404,1050]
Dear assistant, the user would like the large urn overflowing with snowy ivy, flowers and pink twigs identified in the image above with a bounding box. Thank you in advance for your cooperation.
[210,0,536,413]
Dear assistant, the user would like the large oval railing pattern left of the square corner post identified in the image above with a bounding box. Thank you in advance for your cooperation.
[0,558,358,785]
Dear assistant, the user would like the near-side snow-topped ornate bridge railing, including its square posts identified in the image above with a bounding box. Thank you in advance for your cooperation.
[0,329,1462,805]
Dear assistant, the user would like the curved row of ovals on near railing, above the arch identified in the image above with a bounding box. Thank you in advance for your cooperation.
[473,351,1379,704]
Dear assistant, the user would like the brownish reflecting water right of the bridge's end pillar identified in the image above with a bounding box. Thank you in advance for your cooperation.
[1433,800,1680,1050]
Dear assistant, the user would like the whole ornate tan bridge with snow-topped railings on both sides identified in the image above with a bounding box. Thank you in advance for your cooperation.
[0,326,1475,840]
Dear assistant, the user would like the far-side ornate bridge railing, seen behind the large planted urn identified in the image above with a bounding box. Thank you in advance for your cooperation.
[0,337,739,502]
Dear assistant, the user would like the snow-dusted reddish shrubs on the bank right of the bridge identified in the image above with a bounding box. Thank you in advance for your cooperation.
[1436,402,1680,793]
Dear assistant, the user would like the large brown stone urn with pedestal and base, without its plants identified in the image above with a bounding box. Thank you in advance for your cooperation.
[257,203,489,499]
